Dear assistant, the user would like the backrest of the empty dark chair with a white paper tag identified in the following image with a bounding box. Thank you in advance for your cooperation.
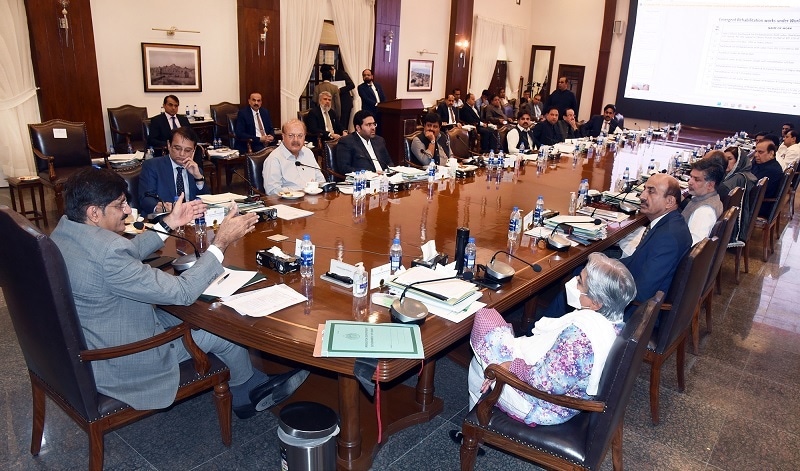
[28,119,92,172]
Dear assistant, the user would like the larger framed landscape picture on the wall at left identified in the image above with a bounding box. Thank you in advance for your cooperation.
[142,43,203,92]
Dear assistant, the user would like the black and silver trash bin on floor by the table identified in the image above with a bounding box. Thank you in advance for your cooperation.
[278,402,339,471]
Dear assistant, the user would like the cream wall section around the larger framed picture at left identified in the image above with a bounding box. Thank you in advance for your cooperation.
[91,0,239,148]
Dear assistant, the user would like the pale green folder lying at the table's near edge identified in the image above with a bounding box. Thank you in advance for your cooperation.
[314,320,425,359]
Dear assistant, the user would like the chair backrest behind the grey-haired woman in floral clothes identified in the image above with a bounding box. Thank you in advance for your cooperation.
[584,291,664,469]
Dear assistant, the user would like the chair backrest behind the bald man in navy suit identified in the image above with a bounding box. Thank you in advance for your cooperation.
[655,237,720,353]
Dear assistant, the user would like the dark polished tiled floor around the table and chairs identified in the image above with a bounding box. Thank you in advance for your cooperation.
[0,189,800,470]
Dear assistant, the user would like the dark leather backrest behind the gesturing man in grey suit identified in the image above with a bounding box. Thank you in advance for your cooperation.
[0,206,98,420]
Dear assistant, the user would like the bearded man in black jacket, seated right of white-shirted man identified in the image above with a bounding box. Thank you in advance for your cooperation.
[336,110,392,175]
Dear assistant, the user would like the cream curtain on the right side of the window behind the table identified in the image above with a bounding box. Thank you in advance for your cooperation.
[331,0,375,127]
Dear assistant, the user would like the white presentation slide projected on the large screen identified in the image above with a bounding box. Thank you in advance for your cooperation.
[620,0,800,128]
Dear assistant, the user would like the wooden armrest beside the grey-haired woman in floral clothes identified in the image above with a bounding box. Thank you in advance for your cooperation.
[476,364,606,425]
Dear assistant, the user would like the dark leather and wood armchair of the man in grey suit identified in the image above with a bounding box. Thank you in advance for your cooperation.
[0,206,231,470]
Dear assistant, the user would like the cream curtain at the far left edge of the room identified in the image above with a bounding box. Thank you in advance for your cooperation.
[0,0,41,183]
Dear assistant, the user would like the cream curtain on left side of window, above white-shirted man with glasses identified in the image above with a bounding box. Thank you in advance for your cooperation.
[281,0,323,125]
